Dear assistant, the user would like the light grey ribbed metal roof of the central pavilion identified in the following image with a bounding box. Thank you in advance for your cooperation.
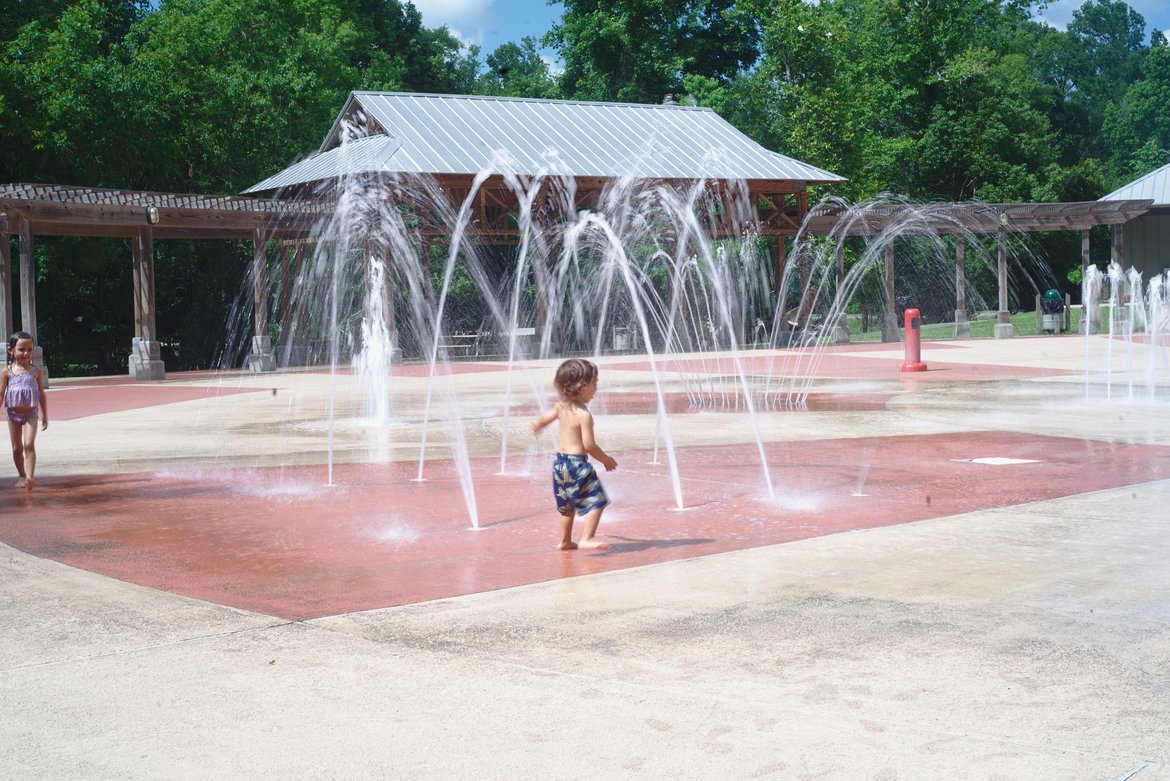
[245,92,845,193]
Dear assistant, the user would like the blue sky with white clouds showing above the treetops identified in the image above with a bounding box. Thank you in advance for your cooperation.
[412,0,1170,61]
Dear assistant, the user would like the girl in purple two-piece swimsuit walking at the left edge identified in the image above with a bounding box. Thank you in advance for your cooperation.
[0,331,49,491]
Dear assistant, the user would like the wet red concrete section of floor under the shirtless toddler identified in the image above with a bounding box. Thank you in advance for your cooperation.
[0,431,1170,620]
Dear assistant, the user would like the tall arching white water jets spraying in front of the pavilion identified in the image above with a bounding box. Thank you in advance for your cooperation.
[237,123,1095,527]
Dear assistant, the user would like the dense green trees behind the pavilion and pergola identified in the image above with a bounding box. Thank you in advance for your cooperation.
[0,0,1170,371]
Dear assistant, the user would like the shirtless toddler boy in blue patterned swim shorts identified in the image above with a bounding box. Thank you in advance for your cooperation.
[532,358,618,551]
